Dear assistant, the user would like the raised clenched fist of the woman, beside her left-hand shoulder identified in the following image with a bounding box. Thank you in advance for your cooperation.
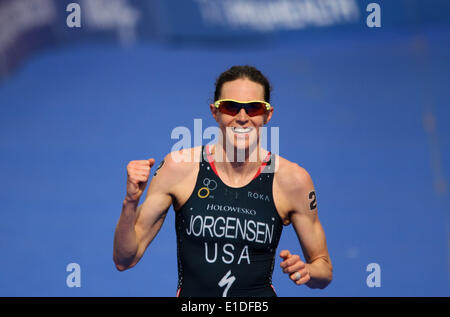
[125,158,155,202]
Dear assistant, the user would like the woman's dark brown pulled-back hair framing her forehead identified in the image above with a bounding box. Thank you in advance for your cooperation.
[214,65,272,102]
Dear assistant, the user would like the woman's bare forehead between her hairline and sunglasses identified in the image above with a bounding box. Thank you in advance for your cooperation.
[220,78,264,101]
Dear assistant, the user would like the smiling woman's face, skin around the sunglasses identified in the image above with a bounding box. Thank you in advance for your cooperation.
[210,78,273,157]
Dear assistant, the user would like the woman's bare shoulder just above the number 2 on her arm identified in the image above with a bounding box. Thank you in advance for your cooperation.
[274,155,313,194]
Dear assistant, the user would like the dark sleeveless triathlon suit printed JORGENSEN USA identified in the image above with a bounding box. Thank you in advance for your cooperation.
[175,146,283,297]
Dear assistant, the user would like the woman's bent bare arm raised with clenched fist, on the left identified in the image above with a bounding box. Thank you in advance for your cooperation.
[113,155,176,271]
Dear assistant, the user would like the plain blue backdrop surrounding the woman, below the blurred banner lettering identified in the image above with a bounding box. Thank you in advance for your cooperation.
[0,2,450,297]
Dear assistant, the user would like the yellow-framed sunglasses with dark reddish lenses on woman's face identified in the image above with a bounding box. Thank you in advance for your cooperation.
[214,99,272,117]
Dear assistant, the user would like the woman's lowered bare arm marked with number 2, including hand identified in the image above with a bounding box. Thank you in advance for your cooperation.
[280,164,333,289]
